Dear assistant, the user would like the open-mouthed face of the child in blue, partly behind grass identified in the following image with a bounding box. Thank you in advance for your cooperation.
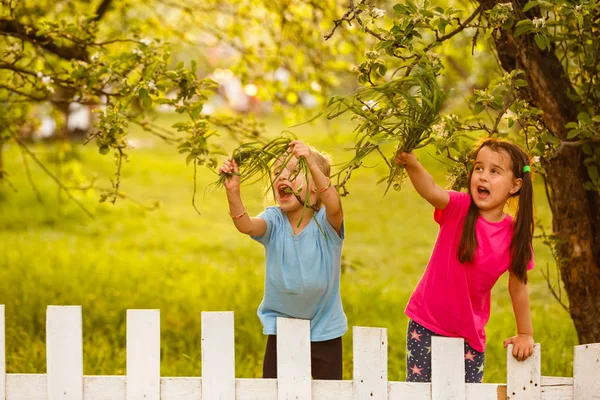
[272,157,315,213]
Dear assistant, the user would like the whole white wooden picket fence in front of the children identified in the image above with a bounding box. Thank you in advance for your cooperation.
[0,305,600,400]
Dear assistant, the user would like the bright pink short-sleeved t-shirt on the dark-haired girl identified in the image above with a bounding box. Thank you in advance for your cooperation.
[405,191,533,352]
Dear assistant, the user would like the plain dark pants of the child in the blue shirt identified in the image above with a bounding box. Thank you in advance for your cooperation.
[263,335,342,380]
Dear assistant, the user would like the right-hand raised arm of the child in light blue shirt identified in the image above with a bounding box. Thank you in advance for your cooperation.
[290,140,344,234]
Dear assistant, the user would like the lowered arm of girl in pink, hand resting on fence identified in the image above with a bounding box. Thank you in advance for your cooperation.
[504,272,534,361]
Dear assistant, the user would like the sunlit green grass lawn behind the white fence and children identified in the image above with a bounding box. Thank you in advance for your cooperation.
[0,113,577,382]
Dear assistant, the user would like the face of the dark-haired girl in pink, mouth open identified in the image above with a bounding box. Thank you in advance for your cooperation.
[470,146,523,221]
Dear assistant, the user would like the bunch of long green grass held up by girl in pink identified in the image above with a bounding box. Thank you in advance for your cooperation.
[327,67,445,193]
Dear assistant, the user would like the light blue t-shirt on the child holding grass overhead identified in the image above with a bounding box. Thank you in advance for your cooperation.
[253,207,348,342]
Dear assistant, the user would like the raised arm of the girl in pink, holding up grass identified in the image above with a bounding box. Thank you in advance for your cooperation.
[396,152,450,210]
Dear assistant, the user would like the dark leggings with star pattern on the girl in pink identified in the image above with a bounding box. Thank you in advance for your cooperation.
[406,320,485,383]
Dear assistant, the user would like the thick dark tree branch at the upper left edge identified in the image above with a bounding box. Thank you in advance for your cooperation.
[0,18,89,62]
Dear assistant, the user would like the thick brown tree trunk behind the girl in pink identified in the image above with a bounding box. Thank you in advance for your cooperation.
[480,0,600,344]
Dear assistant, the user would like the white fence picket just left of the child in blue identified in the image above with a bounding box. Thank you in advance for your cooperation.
[202,312,235,400]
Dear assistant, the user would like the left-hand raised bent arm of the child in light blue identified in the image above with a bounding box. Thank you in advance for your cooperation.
[219,158,267,236]
